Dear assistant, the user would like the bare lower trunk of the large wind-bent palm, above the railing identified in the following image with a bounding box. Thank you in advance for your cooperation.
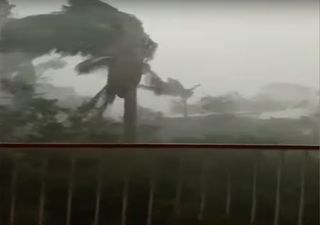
[123,88,137,142]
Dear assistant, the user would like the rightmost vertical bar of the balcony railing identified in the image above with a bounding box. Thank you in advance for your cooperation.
[297,151,308,225]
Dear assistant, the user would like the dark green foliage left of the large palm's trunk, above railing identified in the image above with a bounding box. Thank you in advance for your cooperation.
[0,95,120,142]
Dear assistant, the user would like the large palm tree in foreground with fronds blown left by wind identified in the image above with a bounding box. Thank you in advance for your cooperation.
[0,0,157,142]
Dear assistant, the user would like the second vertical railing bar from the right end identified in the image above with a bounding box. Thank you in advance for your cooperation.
[273,151,284,225]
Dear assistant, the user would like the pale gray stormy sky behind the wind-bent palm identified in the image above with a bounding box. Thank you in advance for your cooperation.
[7,0,319,112]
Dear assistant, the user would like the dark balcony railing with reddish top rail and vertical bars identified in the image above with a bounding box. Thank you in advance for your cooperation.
[0,144,319,225]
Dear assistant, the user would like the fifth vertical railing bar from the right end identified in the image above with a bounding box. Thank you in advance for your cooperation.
[198,161,207,222]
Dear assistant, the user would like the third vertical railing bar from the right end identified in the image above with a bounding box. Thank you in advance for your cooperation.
[250,152,261,225]
